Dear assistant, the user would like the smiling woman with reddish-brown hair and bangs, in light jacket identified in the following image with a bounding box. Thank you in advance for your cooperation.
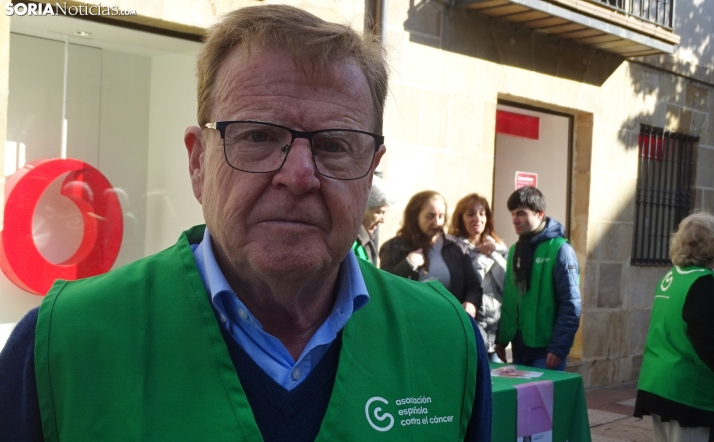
[449,193,508,362]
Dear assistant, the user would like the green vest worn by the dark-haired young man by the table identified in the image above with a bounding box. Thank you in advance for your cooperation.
[496,237,567,348]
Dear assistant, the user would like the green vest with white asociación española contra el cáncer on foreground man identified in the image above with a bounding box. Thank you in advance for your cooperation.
[35,227,476,442]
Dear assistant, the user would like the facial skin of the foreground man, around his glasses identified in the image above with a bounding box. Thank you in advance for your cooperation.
[185,48,385,281]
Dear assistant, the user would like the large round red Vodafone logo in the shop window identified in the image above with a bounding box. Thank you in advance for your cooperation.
[0,159,124,295]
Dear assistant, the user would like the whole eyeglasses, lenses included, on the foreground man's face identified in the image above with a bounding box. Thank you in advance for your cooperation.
[205,121,384,180]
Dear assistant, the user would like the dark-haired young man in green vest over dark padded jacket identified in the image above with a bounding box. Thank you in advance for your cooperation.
[496,186,580,371]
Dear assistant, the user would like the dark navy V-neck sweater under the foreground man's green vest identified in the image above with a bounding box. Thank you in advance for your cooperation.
[0,309,491,442]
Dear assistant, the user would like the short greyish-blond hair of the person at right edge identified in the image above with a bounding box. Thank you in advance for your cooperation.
[669,212,714,267]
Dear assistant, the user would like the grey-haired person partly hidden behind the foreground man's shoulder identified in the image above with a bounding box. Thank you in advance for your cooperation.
[352,175,394,265]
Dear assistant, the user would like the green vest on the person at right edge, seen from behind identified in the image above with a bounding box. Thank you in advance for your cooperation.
[637,267,714,412]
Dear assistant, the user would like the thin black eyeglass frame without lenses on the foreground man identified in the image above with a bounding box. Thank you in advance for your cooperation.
[204,120,384,181]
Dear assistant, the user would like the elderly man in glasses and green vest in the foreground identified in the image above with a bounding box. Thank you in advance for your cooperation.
[0,6,490,441]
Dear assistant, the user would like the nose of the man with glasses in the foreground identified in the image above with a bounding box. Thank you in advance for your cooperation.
[273,139,320,195]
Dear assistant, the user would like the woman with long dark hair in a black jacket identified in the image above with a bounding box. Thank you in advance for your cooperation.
[379,190,483,310]
